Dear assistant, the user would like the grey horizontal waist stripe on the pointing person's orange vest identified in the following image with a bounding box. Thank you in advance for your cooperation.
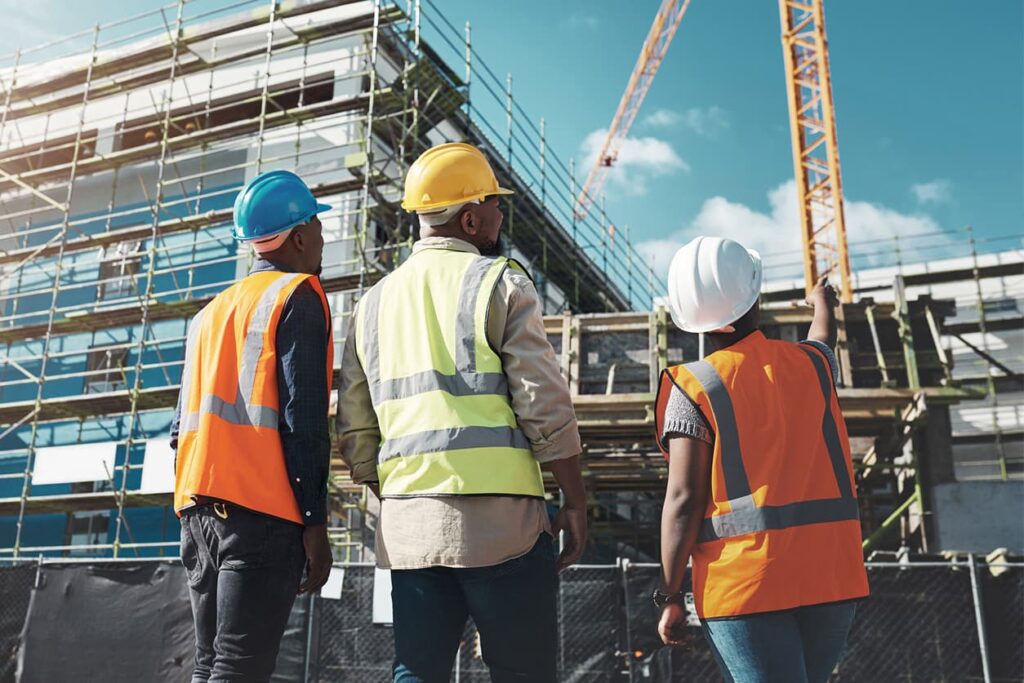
[697,498,860,543]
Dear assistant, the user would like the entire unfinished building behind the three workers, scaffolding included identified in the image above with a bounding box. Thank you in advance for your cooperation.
[0,0,1024,680]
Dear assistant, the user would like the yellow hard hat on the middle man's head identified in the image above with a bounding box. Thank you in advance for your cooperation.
[401,142,514,211]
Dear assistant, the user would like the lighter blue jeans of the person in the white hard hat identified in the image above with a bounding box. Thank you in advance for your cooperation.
[701,602,856,683]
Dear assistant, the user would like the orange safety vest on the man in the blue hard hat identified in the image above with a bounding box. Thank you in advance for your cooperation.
[174,271,334,524]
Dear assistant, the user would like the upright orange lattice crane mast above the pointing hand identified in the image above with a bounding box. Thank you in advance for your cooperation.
[778,0,853,303]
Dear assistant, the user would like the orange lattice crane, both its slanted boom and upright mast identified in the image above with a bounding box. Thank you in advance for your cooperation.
[574,0,853,303]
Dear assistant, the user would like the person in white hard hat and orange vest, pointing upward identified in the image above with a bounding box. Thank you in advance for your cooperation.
[654,237,868,683]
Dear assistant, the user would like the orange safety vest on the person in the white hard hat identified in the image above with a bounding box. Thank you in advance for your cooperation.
[655,331,868,618]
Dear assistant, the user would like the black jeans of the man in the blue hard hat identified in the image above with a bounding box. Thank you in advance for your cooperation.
[181,505,305,683]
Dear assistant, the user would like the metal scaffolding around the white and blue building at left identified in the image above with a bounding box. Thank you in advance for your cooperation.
[0,0,653,559]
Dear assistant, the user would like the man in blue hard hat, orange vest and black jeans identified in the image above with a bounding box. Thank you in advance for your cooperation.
[171,171,334,682]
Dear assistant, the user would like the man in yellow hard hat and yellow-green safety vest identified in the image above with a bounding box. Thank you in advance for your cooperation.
[338,143,587,682]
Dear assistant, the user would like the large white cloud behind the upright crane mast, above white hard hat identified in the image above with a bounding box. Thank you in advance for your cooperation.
[637,180,949,279]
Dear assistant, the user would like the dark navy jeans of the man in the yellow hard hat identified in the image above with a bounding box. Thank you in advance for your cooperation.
[391,533,558,683]
